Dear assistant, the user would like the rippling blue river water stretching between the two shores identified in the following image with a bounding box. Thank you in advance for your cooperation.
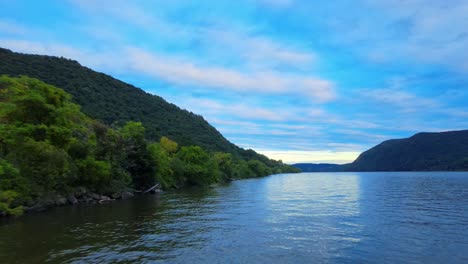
[0,172,468,263]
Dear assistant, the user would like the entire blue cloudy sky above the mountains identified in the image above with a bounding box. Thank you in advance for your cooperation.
[0,0,468,163]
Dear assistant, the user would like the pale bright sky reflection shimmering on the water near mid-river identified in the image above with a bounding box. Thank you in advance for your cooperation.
[265,173,361,260]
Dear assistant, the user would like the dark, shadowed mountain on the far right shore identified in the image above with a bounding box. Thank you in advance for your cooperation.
[344,130,468,171]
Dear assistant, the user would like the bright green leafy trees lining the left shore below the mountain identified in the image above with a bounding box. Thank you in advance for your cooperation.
[0,76,297,215]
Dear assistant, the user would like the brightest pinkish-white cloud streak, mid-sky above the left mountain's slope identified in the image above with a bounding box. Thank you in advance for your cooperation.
[126,48,336,102]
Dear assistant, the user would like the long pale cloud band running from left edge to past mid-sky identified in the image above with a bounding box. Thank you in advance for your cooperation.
[0,39,335,101]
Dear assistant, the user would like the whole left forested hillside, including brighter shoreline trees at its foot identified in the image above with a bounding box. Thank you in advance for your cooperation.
[0,48,299,216]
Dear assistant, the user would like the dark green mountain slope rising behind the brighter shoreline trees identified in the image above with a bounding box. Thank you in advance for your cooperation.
[0,48,272,162]
